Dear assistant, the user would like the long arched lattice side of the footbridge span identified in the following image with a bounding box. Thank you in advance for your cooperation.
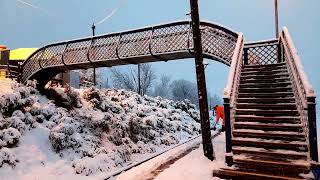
[22,21,238,82]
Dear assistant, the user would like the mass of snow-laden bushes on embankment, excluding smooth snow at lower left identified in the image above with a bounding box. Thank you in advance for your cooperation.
[0,84,200,175]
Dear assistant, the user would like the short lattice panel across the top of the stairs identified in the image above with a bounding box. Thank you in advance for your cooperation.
[243,39,280,65]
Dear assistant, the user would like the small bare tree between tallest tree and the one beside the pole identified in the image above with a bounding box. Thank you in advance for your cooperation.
[153,75,171,98]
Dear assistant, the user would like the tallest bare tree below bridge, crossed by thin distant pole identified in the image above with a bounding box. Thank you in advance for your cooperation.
[111,64,156,95]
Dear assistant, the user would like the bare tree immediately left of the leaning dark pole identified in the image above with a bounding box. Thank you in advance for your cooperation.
[171,79,199,107]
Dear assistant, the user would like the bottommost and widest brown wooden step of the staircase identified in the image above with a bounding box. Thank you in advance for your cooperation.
[213,168,304,180]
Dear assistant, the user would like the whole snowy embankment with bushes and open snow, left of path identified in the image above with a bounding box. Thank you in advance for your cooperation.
[0,79,200,179]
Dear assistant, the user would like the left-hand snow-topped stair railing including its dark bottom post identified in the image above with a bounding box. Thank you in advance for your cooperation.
[223,34,244,165]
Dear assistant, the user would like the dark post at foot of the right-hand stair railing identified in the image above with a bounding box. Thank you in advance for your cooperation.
[308,97,318,162]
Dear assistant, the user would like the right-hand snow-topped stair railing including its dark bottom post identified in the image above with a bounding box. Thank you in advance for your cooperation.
[279,28,318,162]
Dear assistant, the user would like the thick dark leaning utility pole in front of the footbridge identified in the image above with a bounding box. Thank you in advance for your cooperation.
[190,0,215,160]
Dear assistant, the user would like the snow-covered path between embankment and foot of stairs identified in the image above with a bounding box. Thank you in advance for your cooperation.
[116,133,225,180]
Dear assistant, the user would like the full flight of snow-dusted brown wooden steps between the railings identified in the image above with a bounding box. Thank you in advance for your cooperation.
[213,63,311,179]
